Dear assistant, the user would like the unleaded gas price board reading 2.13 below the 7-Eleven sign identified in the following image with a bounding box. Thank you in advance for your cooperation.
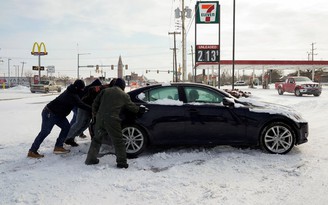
[196,45,220,63]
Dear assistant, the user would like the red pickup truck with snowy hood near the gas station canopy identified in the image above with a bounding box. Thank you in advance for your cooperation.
[275,76,322,96]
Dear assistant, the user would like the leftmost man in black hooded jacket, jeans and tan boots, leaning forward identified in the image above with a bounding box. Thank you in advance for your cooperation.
[27,80,91,158]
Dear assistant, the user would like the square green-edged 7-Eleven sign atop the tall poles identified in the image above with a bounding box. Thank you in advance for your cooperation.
[196,1,219,24]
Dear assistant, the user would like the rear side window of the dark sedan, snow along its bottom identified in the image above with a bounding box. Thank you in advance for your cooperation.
[141,86,179,102]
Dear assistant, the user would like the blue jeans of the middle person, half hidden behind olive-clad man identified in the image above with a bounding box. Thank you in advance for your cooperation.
[67,108,92,139]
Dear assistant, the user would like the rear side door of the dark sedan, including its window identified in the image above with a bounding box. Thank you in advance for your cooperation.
[137,86,185,144]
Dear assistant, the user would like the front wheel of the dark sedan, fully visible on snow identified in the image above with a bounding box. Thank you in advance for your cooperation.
[260,122,295,154]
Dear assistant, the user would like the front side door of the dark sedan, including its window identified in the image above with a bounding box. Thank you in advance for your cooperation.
[184,87,246,144]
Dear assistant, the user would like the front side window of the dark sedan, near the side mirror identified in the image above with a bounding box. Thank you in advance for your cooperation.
[185,87,223,103]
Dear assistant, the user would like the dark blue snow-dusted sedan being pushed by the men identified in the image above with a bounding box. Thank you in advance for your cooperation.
[97,83,308,157]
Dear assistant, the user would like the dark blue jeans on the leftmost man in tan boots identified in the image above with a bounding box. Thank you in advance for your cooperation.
[30,107,70,152]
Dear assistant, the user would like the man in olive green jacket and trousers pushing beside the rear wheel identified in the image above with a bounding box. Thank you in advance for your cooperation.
[85,78,145,168]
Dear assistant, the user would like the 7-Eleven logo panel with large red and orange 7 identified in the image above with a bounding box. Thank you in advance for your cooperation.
[198,2,218,23]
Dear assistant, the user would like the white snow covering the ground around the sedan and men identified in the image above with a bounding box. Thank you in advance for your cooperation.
[0,86,328,205]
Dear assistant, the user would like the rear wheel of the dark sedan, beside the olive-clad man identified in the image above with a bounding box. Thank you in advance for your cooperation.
[122,124,148,158]
